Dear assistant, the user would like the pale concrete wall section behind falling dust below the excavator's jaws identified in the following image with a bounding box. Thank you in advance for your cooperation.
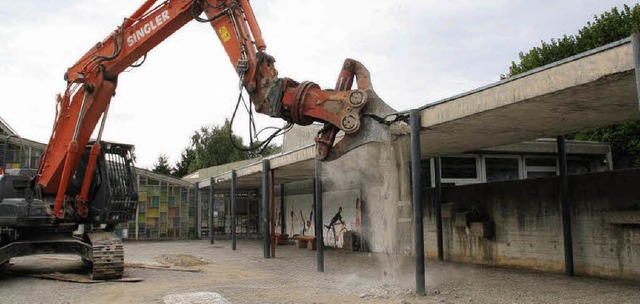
[322,136,412,254]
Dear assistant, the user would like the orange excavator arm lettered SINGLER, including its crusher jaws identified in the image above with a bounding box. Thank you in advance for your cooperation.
[36,0,393,219]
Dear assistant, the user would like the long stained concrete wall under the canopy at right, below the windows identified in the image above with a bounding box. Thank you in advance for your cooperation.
[424,170,640,279]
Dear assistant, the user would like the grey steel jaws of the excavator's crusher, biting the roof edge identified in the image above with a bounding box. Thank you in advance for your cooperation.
[315,58,398,161]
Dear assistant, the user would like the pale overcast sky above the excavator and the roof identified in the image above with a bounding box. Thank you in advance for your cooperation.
[0,0,635,168]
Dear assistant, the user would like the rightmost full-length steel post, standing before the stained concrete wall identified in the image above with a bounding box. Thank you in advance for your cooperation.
[557,135,574,276]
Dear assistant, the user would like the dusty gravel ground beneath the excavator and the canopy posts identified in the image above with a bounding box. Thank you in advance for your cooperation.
[0,240,640,304]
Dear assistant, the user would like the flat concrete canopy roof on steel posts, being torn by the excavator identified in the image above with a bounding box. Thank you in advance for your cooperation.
[200,36,640,190]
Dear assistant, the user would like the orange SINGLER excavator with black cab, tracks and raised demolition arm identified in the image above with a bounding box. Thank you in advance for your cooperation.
[0,0,395,279]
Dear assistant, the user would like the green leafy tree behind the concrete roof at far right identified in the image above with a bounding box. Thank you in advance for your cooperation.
[501,4,640,168]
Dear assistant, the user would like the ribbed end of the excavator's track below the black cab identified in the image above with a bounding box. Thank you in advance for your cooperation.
[87,232,124,280]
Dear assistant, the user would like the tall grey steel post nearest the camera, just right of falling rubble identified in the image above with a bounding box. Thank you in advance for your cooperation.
[410,110,426,296]
